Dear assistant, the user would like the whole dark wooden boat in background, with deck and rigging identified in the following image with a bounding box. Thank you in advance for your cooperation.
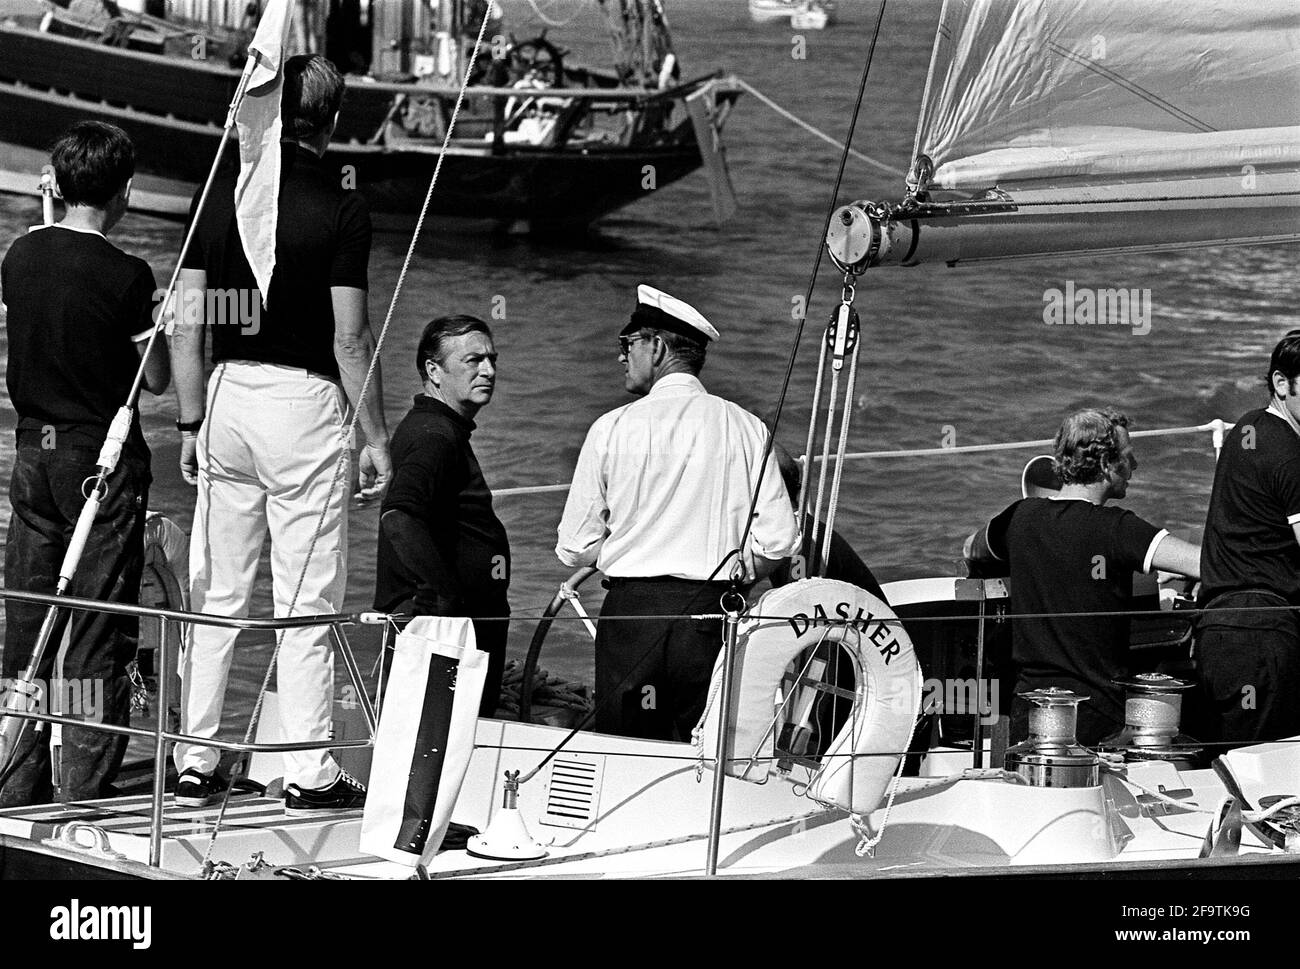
[0,0,738,230]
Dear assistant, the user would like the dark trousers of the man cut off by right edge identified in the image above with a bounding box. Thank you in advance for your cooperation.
[1196,592,1300,743]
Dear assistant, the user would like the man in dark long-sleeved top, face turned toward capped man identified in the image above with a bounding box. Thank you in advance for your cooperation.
[374,316,510,717]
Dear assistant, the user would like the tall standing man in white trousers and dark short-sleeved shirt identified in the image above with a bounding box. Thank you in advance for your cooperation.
[173,56,389,814]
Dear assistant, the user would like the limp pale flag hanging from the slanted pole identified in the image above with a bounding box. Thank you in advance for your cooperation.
[235,0,293,306]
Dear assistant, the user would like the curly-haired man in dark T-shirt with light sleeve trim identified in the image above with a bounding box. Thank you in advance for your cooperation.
[963,408,1200,745]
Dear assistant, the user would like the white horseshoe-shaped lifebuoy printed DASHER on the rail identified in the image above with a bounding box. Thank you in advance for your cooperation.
[699,579,922,814]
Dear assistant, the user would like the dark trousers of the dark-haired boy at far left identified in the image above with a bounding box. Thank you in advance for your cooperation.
[0,444,150,808]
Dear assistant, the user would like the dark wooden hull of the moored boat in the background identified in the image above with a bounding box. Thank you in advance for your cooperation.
[0,27,728,229]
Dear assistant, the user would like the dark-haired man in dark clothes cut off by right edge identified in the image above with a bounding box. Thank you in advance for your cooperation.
[1196,330,1300,741]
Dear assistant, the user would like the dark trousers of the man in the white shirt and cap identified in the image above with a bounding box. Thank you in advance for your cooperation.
[595,579,728,740]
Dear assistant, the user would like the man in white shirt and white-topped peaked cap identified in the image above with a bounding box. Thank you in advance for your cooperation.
[555,285,798,740]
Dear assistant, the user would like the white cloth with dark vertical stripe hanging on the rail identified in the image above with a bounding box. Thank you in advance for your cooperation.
[360,617,488,868]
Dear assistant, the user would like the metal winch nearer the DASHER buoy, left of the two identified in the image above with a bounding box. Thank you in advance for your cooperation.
[1006,687,1101,787]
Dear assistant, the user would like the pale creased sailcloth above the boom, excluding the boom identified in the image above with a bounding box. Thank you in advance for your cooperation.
[915,0,1300,194]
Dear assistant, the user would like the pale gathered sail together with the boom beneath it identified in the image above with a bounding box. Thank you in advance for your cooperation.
[839,0,1300,263]
